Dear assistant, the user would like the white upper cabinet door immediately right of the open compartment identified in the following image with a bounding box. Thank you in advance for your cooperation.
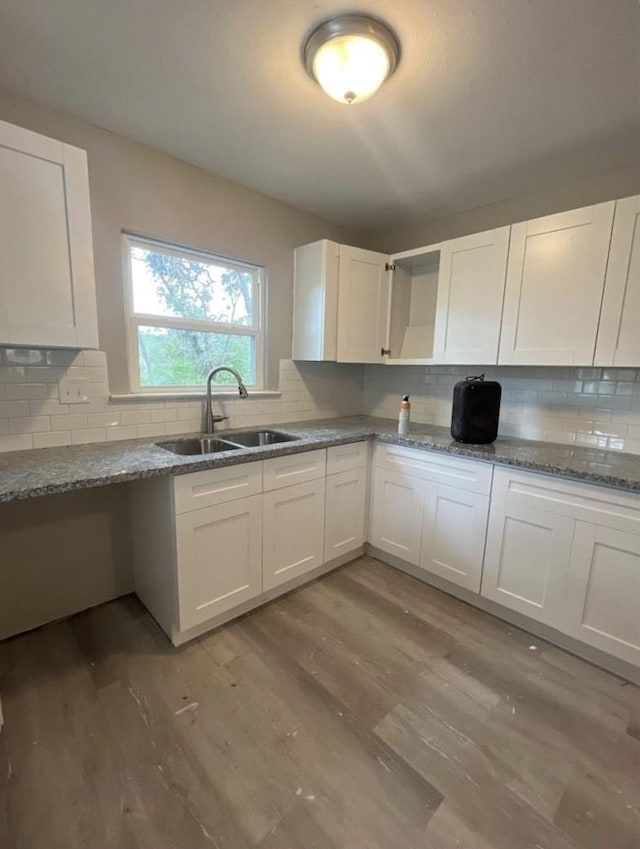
[433,227,511,365]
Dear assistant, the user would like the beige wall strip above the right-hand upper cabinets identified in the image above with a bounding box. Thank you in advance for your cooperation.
[364,162,640,253]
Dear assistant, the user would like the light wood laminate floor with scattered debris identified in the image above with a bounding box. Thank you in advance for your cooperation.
[0,558,640,849]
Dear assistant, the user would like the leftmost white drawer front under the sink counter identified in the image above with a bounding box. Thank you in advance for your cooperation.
[174,462,262,513]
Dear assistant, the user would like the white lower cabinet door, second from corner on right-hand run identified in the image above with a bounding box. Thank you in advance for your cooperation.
[420,483,489,593]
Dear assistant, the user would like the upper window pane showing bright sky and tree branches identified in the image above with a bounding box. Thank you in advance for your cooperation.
[130,244,255,327]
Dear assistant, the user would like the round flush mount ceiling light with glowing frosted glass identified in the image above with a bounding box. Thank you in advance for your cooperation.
[304,15,400,103]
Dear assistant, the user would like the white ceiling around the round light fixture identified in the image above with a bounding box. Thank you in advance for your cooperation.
[0,0,640,227]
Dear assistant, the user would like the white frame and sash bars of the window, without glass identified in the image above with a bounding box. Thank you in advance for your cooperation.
[122,233,266,395]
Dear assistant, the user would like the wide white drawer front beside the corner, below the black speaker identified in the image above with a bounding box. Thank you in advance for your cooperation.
[375,445,493,495]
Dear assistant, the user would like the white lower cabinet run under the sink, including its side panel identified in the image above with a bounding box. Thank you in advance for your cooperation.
[131,441,369,645]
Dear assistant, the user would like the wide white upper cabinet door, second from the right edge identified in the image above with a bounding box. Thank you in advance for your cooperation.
[499,201,615,365]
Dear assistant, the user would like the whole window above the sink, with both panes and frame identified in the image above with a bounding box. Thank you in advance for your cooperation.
[124,236,263,391]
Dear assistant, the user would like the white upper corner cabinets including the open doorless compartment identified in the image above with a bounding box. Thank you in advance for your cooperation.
[293,227,510,365]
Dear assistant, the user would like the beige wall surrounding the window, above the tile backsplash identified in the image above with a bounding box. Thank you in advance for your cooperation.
[0,88,353,393]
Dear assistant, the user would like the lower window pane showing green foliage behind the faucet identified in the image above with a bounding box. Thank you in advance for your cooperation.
[138,326,256,388]
